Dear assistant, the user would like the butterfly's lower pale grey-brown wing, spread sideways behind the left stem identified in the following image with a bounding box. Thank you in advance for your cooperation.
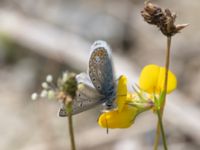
[59,73,105,117]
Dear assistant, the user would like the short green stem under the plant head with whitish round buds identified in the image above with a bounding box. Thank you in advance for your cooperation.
[67,102,76,150]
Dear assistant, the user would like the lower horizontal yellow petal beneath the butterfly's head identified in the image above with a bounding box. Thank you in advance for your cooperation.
[98,106,137,129]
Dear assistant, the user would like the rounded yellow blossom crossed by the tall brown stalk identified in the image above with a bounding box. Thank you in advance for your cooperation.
[139,64,177,94]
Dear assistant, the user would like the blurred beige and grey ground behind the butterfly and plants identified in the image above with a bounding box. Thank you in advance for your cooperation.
[0,0,200,150]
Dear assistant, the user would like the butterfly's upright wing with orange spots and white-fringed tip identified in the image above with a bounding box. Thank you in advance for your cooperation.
[88,41,116,106]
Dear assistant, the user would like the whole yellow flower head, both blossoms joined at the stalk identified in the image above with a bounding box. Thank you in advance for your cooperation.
[98,65,177,128]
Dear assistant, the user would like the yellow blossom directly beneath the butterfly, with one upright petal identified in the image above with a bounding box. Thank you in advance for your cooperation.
[98,75,138,128]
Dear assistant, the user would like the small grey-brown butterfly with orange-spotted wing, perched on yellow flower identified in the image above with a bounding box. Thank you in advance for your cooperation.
[59,40,116,117]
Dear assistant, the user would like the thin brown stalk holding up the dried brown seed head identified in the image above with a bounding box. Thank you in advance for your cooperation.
[154,36,171,150]
